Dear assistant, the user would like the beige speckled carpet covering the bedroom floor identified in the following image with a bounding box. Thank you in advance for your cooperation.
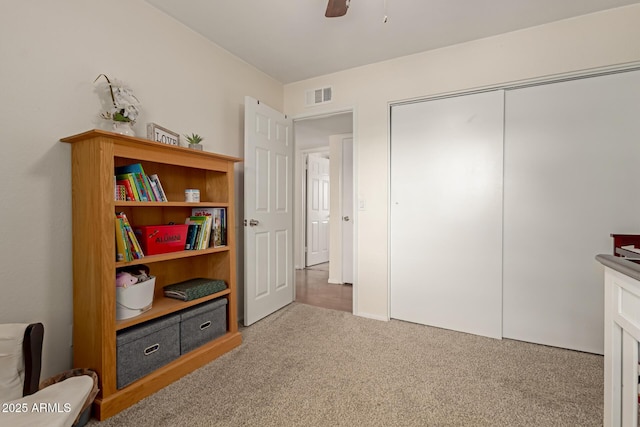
[89,303,603,427]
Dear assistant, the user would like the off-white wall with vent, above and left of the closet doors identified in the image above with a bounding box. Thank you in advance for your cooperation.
[284,5,640,319]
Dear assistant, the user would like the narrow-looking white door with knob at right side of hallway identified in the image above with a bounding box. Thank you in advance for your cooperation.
[342,138,353,283]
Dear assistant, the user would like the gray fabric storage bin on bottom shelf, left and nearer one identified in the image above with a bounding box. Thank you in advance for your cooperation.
[116,314,180,389]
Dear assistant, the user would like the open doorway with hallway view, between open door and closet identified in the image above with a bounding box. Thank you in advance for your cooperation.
[294,111,354,312]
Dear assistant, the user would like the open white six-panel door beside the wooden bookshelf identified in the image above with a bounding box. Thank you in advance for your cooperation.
[244,97,294,326]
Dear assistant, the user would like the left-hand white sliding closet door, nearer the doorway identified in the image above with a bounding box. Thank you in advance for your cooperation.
[390,91,504,338]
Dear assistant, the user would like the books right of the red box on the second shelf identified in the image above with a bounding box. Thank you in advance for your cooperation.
[185,208,227,250]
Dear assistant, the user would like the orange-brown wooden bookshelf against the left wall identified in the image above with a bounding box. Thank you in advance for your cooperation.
[61,130,242,420]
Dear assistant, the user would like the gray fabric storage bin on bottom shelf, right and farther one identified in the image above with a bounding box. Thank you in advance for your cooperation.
[180,298,227,354]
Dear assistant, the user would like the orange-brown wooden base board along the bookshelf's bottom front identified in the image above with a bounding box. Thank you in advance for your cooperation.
[93,331,242,421]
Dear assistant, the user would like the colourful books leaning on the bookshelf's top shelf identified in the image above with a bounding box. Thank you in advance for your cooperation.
[115,163,168,202]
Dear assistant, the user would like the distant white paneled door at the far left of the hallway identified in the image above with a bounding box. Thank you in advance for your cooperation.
[306,154,330,267]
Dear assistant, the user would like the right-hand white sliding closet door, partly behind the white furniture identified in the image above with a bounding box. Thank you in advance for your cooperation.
[503,72,640,354]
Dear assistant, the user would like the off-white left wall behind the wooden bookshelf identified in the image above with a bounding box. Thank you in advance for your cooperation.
[0,0,283,379]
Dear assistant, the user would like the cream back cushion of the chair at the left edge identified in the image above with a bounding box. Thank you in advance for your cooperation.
[0,323,29,402]
